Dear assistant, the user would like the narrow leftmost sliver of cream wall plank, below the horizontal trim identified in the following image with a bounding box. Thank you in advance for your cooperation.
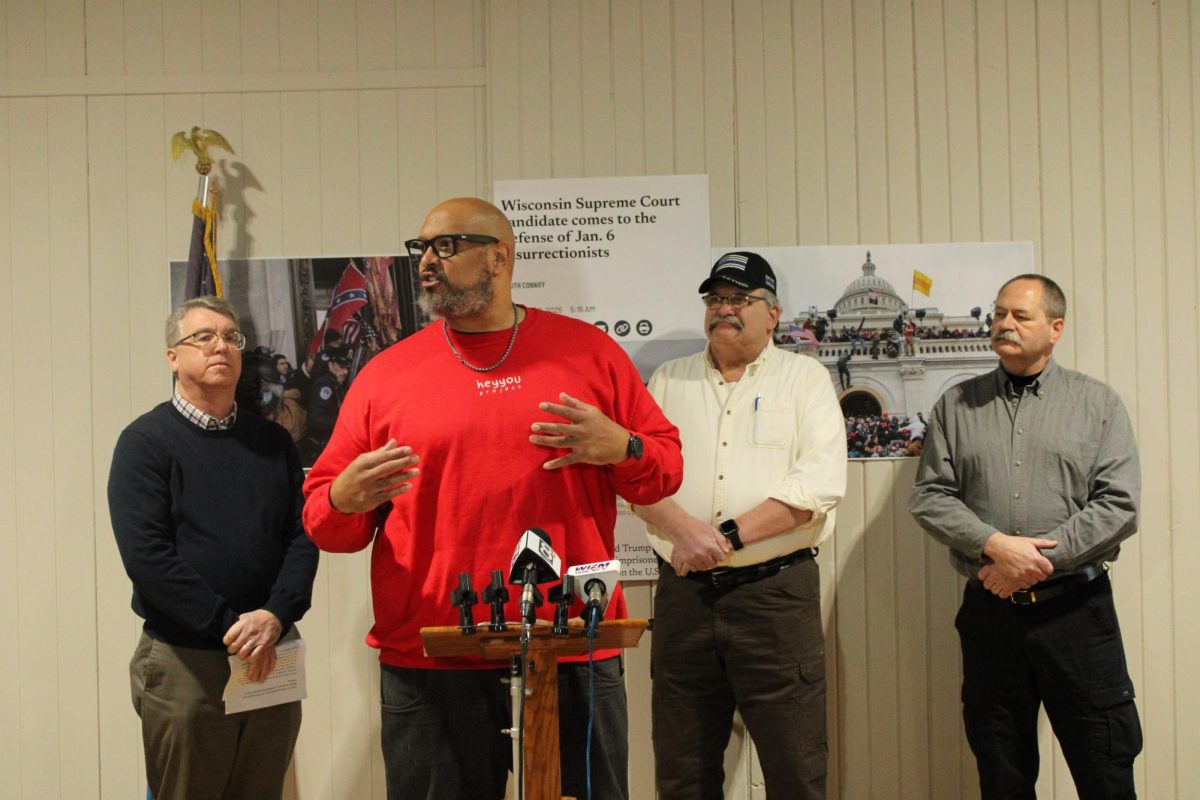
[0,97,23,798]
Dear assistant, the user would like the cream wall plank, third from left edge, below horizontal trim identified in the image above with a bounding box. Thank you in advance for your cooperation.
[43,97,103,798]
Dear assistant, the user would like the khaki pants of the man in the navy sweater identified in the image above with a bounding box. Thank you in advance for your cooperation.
[130,628,300,800]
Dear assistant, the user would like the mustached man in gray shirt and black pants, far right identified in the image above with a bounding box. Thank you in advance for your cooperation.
[908,275,1141,800]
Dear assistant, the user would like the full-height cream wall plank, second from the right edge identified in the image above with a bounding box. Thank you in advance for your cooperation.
[1127,2,1180,798]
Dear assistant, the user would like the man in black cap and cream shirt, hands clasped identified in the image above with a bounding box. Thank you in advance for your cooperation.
[635,252,846,799]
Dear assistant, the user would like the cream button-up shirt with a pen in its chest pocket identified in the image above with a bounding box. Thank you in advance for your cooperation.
[647,343,846,567]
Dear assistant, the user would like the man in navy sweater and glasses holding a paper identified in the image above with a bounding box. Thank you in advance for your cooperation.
[108,297,317,800]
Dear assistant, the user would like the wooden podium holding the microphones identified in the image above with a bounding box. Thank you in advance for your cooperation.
[421,619,647,800]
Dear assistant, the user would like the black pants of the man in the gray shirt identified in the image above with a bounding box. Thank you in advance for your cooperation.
[955,575,1141,800]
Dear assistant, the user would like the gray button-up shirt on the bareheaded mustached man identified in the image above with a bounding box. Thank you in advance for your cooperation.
[908,360,1141,577]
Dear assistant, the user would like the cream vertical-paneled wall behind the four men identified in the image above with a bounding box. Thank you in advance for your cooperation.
[0,0,1200,800]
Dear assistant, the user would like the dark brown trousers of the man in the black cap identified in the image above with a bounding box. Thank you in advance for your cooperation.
[650,559,828,800]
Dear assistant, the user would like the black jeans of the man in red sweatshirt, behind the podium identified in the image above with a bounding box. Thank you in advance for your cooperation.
[379,658,629,800]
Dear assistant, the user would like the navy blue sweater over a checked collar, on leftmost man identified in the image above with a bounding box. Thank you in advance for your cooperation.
[108,402,317,649]
